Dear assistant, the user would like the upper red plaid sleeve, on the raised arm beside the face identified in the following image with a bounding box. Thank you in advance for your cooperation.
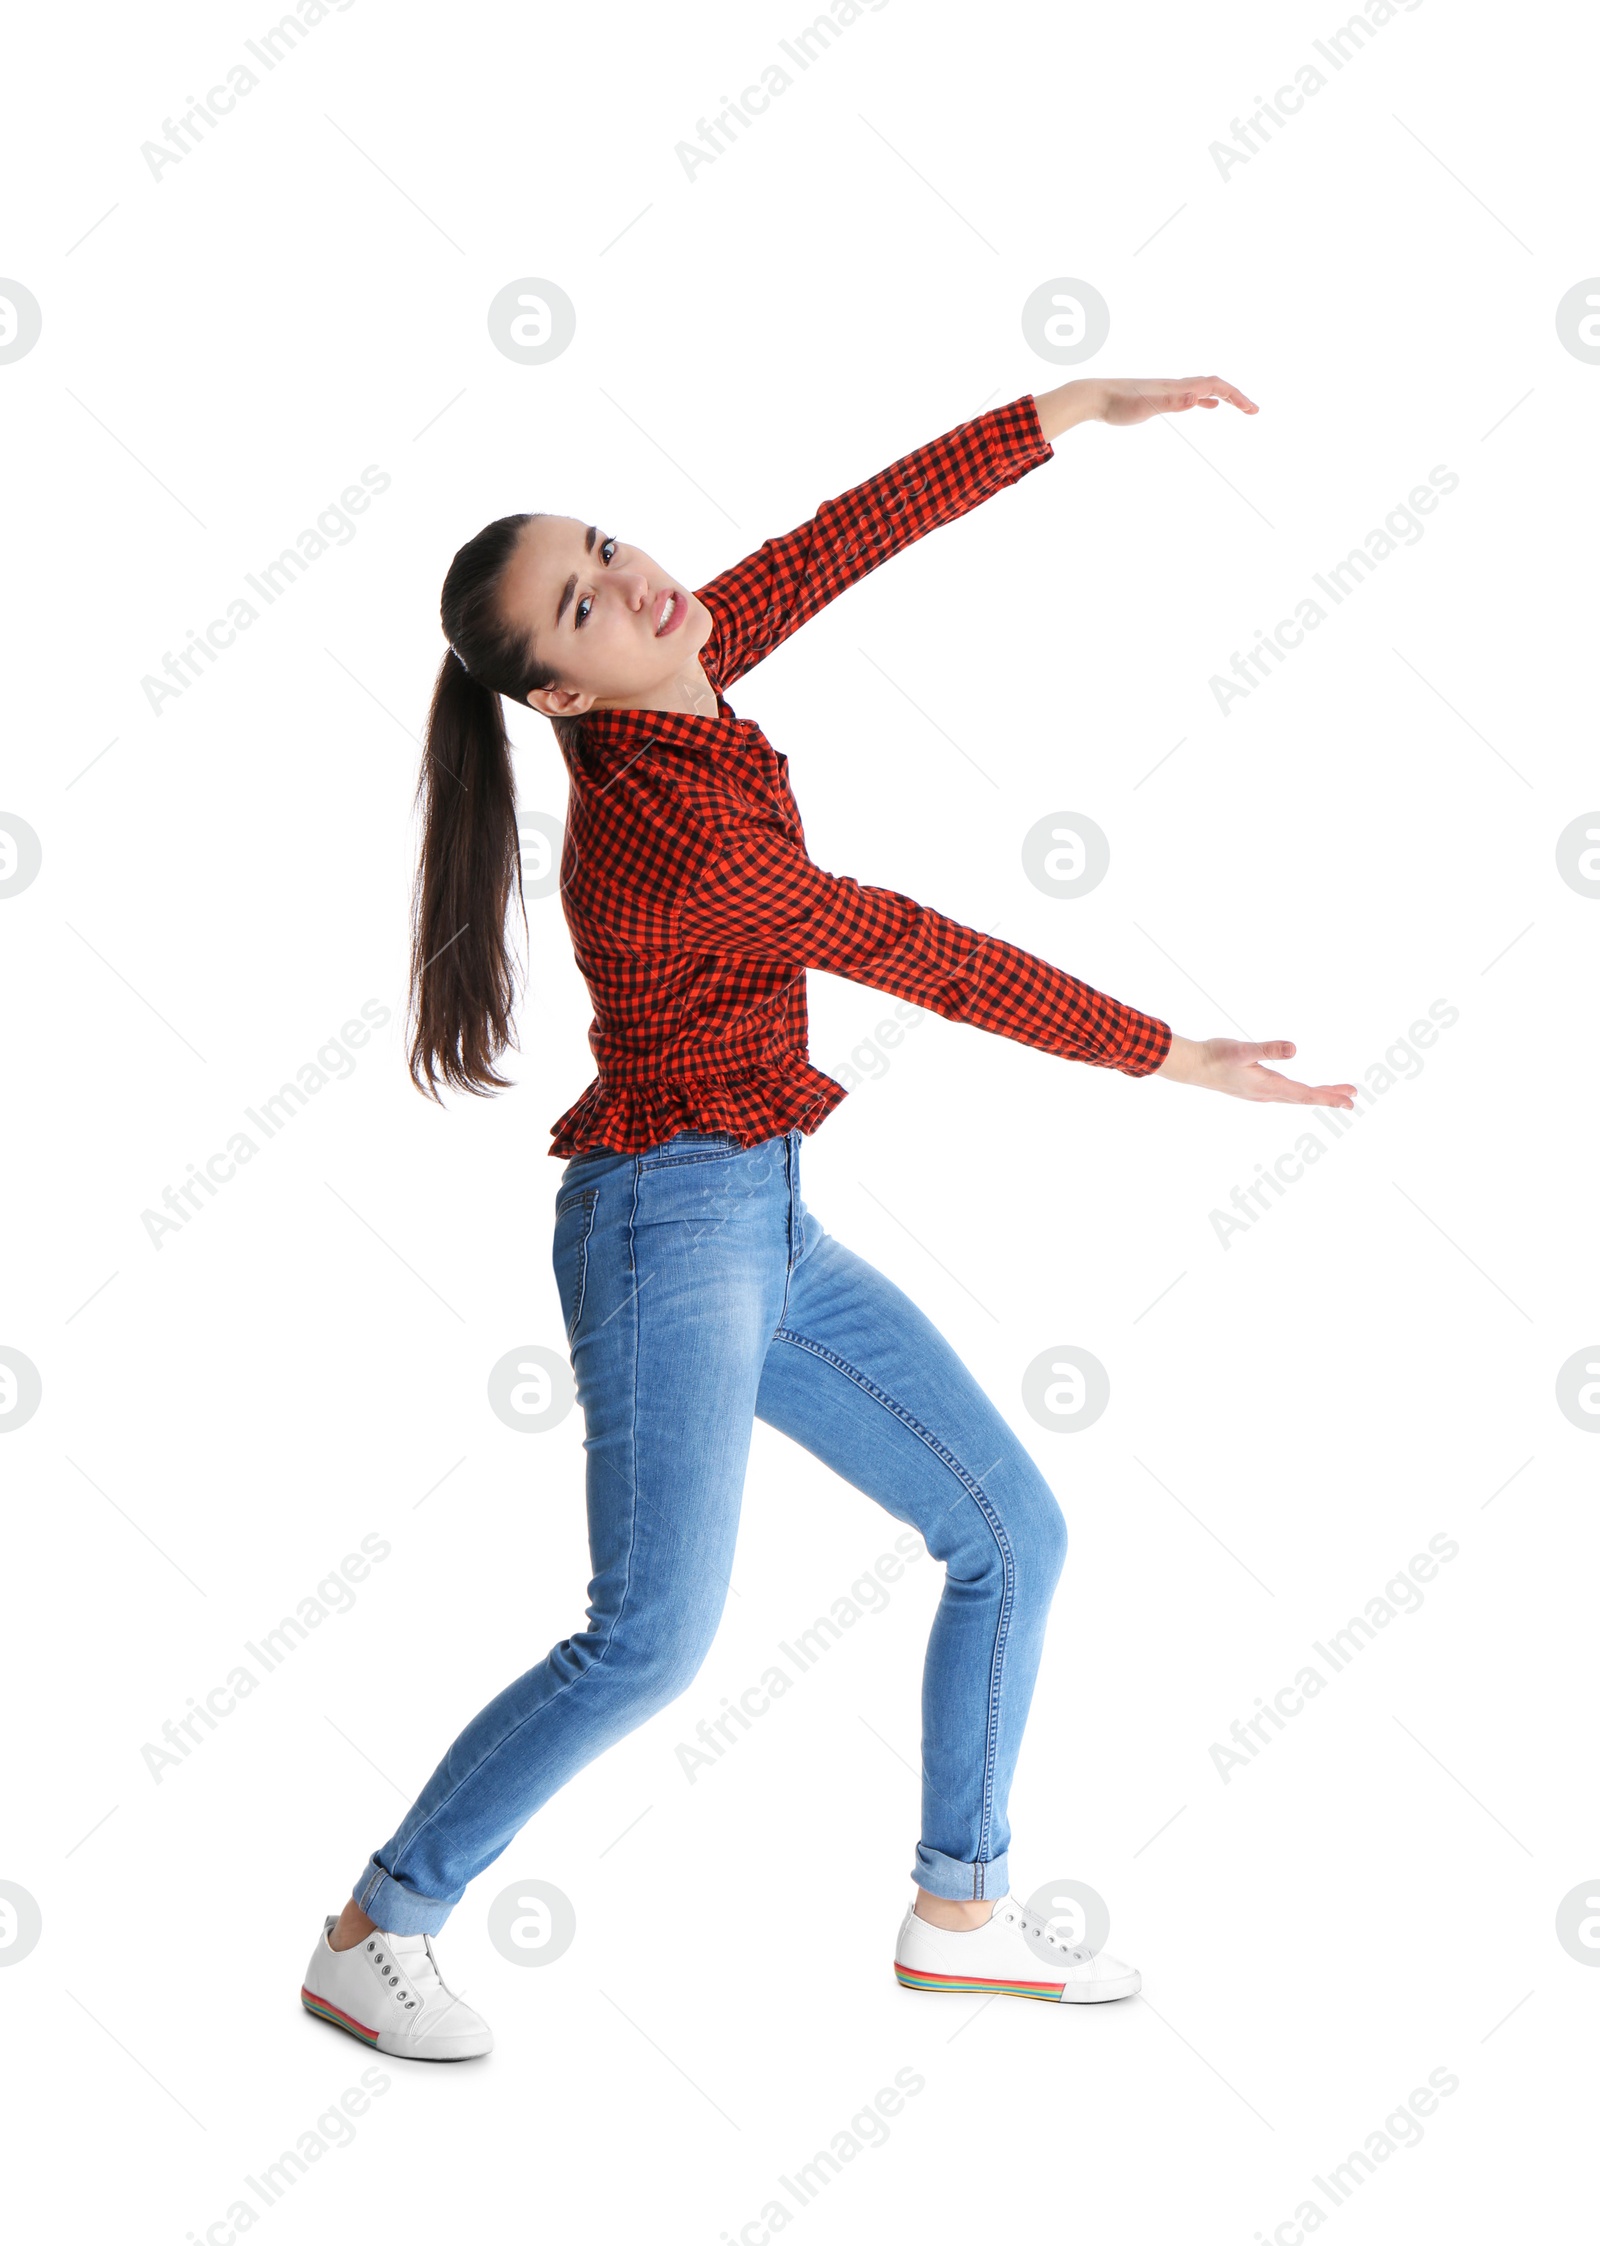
[697,393,1054,687]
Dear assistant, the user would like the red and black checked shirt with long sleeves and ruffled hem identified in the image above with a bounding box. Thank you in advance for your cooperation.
[551,395,1171,1154]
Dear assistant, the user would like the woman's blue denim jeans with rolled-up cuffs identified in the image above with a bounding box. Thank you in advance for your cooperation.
[353,1132,1067,1934]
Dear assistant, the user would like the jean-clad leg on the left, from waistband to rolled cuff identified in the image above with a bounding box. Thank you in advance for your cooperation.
[351,1134,789,1938]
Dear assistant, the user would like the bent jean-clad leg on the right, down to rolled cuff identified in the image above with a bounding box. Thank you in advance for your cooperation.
[755,1167,1067,1916]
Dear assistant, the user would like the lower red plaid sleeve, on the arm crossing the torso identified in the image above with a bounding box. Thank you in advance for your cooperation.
[676,827,1173,1076]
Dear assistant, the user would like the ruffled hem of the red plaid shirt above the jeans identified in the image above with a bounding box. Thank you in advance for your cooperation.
[551,1056,847,1157]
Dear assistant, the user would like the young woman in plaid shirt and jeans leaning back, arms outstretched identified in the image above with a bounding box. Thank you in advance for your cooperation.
[301,377,1355,2060]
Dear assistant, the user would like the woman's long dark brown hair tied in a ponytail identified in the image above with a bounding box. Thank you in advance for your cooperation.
[409,514,575,1098]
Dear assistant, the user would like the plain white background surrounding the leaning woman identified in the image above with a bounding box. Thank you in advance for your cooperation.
[0,0,1600,2246]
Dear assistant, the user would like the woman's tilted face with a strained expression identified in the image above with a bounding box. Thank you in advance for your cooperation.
[501,514,712,716]
